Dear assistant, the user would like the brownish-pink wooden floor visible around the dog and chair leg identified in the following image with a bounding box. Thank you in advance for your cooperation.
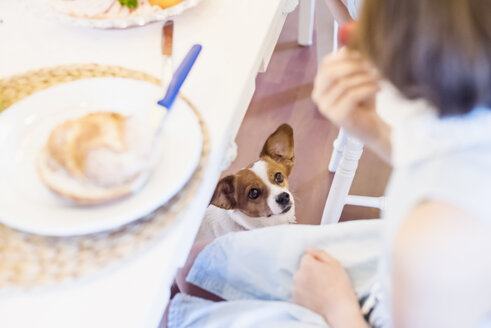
[224,9,390,224]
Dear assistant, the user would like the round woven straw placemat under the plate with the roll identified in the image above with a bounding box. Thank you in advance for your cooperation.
[0,64,209,288]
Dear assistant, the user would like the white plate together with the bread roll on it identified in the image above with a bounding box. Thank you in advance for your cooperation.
[0,78,203,236]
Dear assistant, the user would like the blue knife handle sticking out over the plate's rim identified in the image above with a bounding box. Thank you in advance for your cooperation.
[158,44,201,110]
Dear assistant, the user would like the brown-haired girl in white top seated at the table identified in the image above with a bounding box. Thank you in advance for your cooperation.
[169,0,491,328]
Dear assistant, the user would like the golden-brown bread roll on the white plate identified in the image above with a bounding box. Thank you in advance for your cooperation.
[38,112,152,204]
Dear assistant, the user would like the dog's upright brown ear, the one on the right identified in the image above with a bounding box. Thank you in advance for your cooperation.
[259,124,295,175]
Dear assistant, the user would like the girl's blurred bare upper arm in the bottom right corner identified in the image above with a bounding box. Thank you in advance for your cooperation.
[392,201,491,328]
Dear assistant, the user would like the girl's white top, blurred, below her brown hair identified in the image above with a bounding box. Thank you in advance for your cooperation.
[372,108,491,327]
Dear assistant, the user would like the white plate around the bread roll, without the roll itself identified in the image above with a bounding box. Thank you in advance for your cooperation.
[0,78,202,235]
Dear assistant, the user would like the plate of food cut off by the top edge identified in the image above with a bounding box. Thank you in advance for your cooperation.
[45,0,200,29]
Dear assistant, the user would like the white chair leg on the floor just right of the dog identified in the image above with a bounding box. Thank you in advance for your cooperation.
[321,137,363,224]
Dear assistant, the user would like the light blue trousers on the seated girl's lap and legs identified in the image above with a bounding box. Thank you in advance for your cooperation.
[169,220,382,328]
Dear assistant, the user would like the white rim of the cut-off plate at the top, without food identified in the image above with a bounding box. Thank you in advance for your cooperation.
[45,0,201,29]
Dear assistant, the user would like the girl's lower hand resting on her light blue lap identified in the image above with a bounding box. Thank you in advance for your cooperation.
[293,249,367,328]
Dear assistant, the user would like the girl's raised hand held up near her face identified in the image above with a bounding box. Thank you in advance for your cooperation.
[312,48,380,142]
